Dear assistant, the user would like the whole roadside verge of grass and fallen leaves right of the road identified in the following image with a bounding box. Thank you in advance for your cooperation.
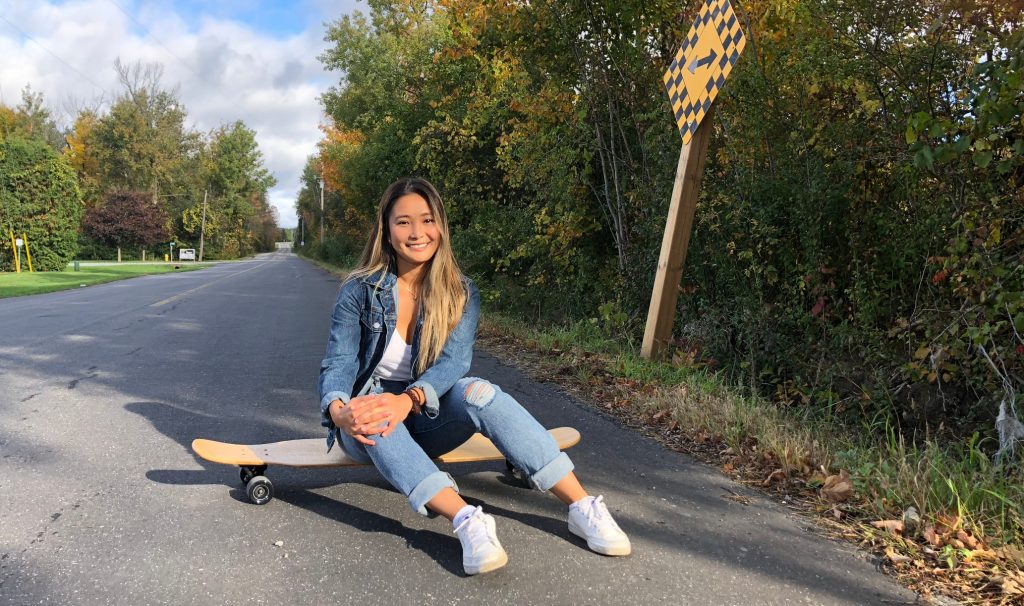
[479,313,1024,606]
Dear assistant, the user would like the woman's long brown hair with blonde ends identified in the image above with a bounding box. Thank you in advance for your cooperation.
[347,177,467,375]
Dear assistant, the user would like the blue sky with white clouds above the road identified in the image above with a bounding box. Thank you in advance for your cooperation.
[0,0,368,227]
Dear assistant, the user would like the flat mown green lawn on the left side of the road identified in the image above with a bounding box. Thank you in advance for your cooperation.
[0,263,204,299]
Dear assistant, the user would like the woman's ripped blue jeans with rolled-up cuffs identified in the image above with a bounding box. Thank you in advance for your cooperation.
[340,378,572,515]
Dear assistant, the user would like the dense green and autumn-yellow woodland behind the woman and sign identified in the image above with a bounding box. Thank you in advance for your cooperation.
[315,0,1024,431]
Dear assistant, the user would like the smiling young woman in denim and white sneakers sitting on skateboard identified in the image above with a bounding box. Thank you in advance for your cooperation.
[319,177,631,574]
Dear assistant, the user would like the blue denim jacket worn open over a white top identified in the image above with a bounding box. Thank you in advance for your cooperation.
[318,271,480,450]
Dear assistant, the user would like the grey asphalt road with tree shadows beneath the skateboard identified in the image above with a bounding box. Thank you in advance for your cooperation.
[0,253,914,605]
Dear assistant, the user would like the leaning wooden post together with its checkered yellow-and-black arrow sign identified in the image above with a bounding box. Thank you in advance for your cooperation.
[640,0,746,358]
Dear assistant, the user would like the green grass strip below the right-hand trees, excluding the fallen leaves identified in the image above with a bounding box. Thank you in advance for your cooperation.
[481,312,1024,545]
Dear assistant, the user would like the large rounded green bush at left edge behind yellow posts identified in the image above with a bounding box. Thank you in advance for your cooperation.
[0,136,83,271]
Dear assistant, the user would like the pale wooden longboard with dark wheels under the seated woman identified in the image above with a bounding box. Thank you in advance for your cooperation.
[193,427,580,505]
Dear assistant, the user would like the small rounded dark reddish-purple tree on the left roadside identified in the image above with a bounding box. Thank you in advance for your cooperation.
[82,191,168,263]
